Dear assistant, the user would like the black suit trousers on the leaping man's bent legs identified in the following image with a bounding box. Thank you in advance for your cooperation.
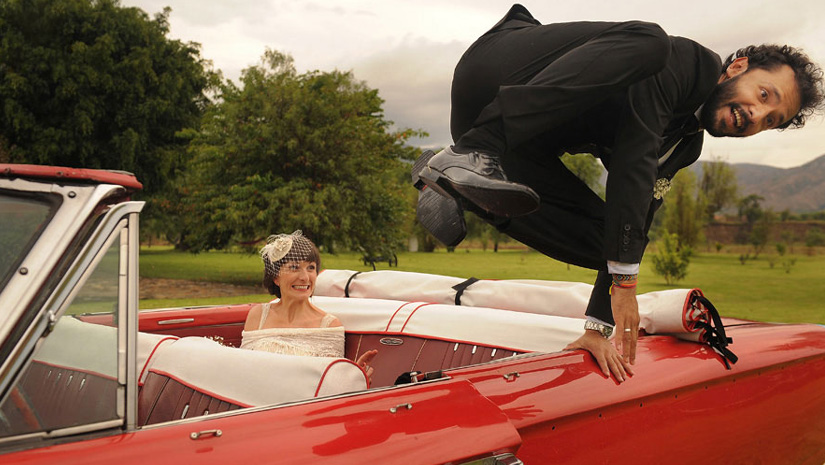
[450,21,670,323]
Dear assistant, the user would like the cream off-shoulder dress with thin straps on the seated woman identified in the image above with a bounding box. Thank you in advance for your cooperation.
[241,302,344,357]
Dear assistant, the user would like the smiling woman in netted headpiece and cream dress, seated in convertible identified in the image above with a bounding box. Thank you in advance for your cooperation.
[241,231,378,377]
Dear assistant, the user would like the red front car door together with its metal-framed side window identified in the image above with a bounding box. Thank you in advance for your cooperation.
[0,186,520,464]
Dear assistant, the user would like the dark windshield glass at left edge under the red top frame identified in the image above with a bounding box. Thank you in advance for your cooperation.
[0,192,57,289]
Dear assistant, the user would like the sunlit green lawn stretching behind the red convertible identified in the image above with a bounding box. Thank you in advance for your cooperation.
[140,247,825,324]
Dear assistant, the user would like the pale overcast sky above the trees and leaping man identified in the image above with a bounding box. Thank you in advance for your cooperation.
[121,0,825,168]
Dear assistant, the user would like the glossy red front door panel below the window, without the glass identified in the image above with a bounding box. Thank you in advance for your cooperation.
[3,380,520,465]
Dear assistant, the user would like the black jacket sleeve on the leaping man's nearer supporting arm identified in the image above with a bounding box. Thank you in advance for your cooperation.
[604,37,721,263]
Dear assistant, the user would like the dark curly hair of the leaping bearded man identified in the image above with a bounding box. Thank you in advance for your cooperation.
[723,44,825,129]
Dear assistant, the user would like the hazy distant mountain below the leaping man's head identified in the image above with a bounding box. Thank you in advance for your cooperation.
[731,155,825,213]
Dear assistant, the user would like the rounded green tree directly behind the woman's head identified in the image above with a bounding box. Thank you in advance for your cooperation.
[170,50,417,254]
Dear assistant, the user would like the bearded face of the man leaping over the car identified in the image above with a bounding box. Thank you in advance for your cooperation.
[701,58,800,137]
